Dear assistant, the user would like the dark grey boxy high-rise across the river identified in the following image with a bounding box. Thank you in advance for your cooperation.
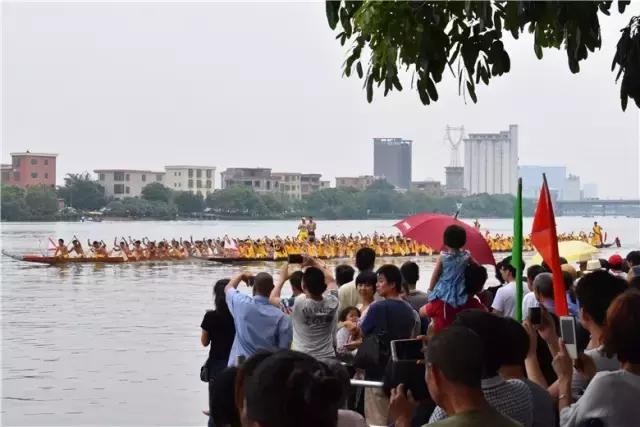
[373,138,412,190]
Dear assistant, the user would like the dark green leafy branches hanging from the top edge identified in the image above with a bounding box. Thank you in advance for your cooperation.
[326,0,640,107]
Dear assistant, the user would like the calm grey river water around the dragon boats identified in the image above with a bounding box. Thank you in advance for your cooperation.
[0,217,640,425]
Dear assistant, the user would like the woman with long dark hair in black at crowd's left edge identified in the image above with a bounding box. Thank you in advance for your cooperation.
[200,279,236,426]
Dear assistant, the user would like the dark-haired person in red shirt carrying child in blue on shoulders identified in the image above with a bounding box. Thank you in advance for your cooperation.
[420,263,489,334]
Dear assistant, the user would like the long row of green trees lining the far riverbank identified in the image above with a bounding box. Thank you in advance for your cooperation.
[1,174,535,221]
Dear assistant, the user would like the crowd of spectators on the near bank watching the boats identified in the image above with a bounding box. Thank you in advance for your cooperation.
[201,230,640,427]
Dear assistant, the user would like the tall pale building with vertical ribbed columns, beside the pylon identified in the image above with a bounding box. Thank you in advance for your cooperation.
[464,125,518,194]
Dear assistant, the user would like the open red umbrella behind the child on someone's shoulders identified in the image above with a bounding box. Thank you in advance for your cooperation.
[394,213,496,265]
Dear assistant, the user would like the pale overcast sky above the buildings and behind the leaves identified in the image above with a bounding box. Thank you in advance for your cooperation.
[2,2,640,198]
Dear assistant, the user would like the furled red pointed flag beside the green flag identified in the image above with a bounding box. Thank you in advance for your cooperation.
[531,174,569,316]
